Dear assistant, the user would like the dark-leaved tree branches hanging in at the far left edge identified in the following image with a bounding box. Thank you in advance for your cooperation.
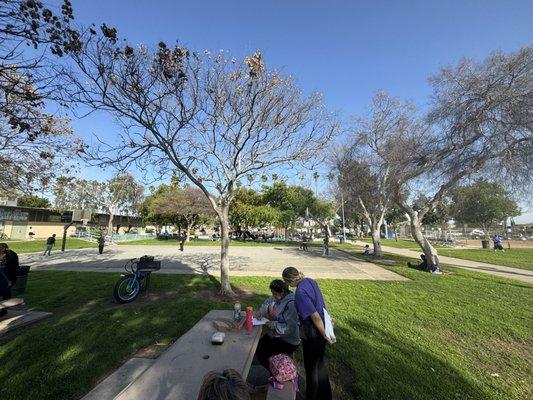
[0,0,81,193]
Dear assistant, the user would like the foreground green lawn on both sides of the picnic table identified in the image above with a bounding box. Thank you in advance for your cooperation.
[0,266,533,400]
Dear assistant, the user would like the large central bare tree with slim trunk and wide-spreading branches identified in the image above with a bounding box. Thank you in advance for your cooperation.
[63,26,337,294]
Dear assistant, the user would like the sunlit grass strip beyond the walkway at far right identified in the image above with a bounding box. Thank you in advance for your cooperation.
[439,249,533,271]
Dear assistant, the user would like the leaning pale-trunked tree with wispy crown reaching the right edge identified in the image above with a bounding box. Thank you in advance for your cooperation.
[360,46,533,266]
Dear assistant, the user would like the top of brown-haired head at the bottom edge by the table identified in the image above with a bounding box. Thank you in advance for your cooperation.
[198,368,250,400]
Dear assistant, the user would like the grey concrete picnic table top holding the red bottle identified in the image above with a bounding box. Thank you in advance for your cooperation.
[115,310,261,400]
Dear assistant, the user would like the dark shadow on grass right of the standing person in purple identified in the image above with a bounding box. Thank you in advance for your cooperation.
[329,319,490,400]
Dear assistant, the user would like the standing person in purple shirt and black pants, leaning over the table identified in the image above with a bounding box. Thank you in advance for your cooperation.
[282,267,335,400]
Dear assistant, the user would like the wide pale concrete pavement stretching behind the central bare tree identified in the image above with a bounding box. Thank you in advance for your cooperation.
[20,245,407,281]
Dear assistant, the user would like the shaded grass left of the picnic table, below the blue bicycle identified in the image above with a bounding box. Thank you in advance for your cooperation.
[0,271,259,400]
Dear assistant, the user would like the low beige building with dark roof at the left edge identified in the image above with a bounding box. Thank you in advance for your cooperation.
[0,202,142,240]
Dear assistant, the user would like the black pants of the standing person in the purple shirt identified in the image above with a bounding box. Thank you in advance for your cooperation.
[302,333,332,400]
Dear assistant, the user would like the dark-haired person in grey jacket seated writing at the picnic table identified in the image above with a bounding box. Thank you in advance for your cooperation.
[256,279,300,369]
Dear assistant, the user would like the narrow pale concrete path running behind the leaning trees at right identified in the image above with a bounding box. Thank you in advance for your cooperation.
[355,241,533,283]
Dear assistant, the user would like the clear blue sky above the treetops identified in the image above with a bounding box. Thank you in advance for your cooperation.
[60,0,533,219]
